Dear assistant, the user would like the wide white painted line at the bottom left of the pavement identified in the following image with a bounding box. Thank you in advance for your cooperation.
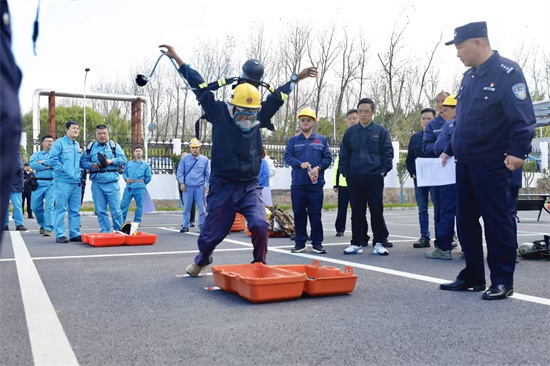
[10,232,78,365]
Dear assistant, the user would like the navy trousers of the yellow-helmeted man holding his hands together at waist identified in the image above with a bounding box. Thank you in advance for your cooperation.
[290,184,324,248]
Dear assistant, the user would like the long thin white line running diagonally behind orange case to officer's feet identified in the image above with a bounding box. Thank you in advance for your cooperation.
[170,232,550,306]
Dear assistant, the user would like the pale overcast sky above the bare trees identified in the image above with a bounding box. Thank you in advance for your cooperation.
[9,0,550,112]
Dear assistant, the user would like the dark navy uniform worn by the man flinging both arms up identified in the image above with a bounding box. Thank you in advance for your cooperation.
[179,64,286,266]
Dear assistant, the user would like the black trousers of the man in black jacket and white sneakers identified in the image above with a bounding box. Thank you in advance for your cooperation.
[346,174,389,246]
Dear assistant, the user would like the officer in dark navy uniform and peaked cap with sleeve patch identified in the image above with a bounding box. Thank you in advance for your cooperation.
[440,22,536,300]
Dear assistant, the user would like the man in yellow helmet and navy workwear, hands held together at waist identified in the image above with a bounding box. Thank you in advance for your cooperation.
[283,108,332,254]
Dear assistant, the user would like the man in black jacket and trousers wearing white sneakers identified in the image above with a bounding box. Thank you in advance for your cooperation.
[339,98,393,255]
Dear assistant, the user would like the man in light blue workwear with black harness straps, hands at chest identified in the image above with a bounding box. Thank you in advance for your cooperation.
[80,125,126,233]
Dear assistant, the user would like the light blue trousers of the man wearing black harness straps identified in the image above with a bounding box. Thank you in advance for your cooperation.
[92,181,123,233]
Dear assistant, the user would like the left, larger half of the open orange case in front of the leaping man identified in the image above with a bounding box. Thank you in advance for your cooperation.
[212,263,306,303]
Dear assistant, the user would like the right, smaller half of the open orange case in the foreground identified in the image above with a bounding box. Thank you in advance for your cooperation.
[273,261,357,296]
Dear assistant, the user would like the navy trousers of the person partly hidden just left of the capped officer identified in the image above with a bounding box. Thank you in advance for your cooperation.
[433,184,456,251]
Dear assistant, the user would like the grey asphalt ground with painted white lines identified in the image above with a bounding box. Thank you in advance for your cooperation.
[0,210,550,365]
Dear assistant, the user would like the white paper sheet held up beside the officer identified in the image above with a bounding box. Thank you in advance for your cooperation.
[416,156,456,187]
